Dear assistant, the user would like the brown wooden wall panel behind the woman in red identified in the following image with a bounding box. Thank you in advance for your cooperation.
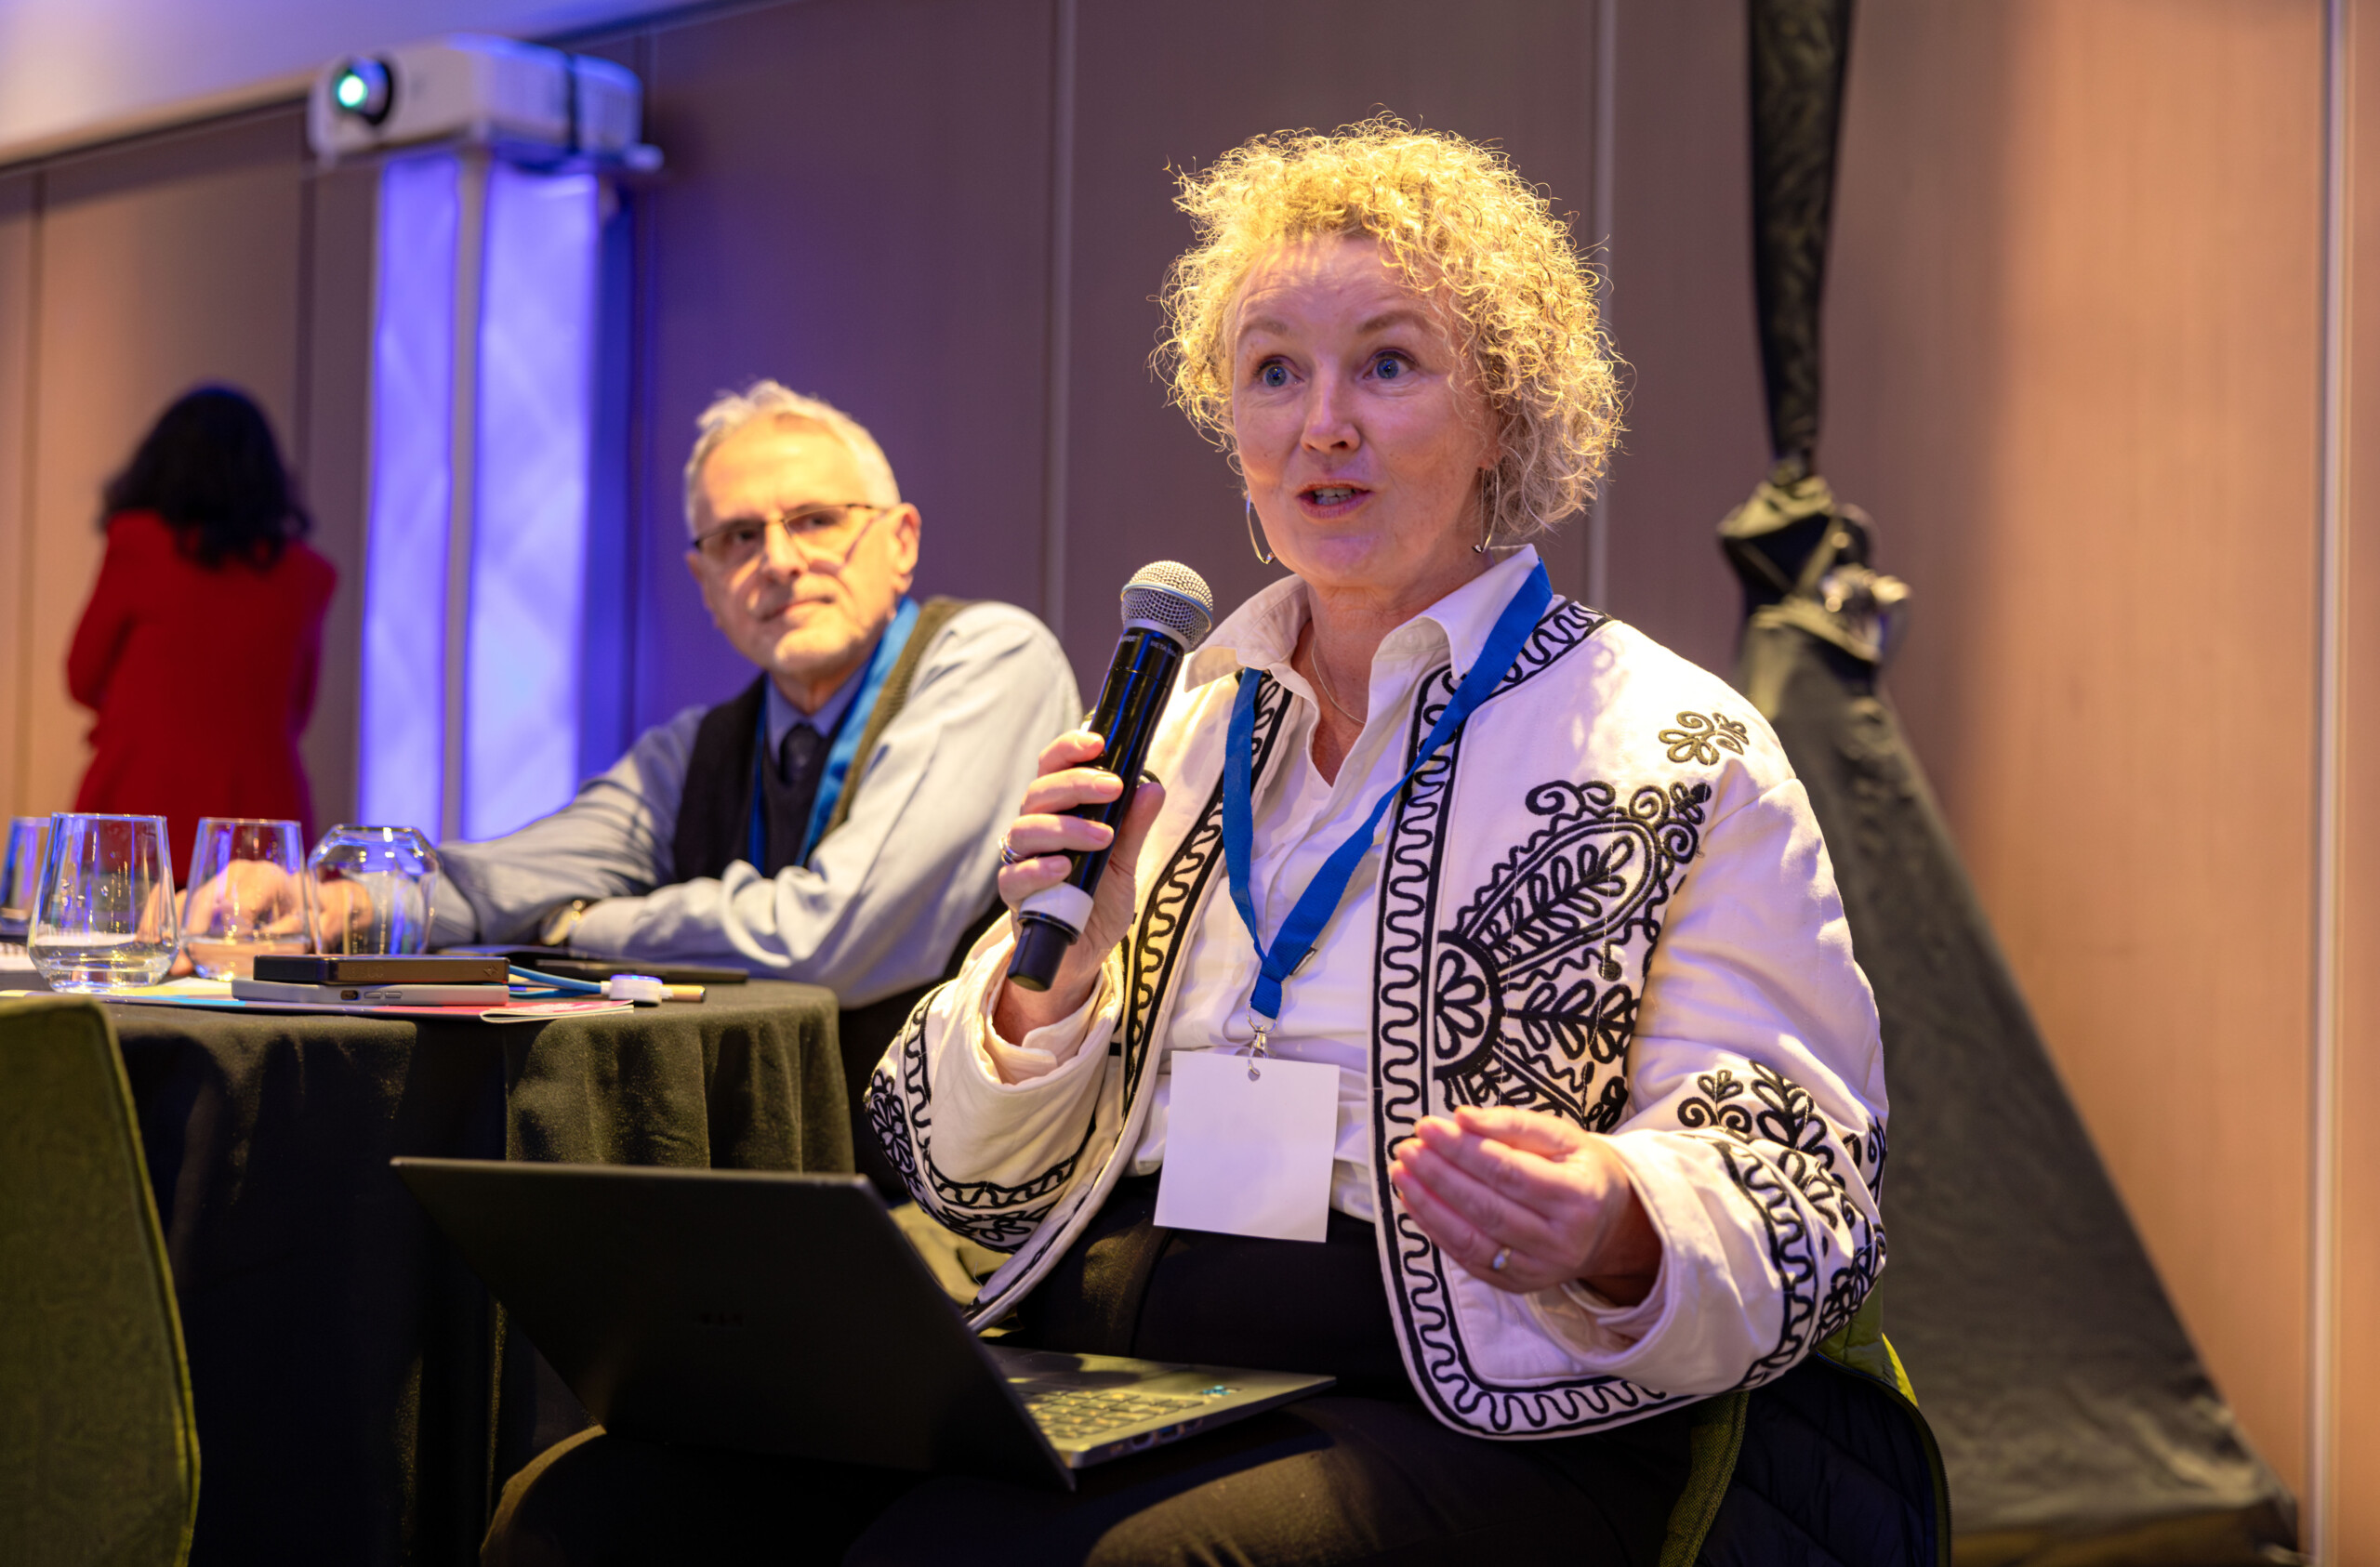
[14,110,302,832]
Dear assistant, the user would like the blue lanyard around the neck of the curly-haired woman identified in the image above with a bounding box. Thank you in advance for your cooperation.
[1223,561,1554,1032]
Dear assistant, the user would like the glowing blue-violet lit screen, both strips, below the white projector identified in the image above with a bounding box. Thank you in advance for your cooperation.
[360,152,602,837]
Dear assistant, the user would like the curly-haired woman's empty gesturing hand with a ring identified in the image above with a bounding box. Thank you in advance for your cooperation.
[1387,1106,1661,1306]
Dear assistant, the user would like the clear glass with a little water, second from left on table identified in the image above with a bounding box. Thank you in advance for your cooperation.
[26,810,181,992]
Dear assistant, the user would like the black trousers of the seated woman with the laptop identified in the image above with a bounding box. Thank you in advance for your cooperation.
[481,1182,1690,1567]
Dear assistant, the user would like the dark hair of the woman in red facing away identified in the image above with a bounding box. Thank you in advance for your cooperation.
[100,385,314,571]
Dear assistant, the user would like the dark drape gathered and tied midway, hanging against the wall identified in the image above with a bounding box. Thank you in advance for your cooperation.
[1718,0,2294,1567]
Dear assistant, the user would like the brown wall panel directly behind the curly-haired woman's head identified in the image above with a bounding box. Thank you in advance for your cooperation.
[1064,0,1594,699]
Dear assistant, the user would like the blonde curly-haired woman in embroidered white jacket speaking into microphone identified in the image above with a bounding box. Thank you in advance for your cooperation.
[488,119,1921,1564]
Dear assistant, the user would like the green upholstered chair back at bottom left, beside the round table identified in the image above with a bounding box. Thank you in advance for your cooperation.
[0,999,197,1567]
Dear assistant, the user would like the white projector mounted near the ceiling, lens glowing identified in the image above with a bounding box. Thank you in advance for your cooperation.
[307,33,659,169]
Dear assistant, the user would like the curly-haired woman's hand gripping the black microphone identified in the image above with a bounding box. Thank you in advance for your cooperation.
[993,730,1166,1044]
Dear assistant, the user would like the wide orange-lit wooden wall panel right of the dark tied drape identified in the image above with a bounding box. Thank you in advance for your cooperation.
[1823,0,2323,1486]
